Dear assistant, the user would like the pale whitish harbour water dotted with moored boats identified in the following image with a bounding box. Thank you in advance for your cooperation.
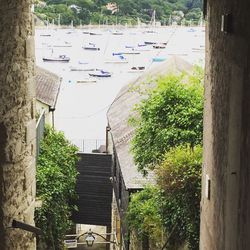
[35,27,205,151]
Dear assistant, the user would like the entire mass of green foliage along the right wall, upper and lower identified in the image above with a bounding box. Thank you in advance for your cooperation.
[127,68,203,250]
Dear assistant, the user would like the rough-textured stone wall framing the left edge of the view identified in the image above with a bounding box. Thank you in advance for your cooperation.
[0,0,36,250]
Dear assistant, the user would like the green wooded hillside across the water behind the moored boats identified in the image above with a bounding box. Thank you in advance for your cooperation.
[35,0,202,25]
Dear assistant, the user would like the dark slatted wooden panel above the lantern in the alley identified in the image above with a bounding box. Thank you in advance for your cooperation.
[72,153,112,226]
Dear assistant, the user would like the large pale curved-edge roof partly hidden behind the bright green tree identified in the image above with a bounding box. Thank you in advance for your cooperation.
[107,57,192,189]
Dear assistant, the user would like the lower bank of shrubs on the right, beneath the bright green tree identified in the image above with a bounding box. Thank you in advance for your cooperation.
[126,145,202,250]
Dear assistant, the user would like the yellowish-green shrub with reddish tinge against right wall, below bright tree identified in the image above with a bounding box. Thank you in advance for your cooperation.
[156,145,202,250]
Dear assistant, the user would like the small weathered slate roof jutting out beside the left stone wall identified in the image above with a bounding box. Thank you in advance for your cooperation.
[35,66,61,108]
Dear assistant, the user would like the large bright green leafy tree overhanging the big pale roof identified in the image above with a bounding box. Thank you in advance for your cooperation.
[130,68,203,174]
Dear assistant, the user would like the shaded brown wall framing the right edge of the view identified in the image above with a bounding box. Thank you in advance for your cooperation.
[200,0,250,250]
